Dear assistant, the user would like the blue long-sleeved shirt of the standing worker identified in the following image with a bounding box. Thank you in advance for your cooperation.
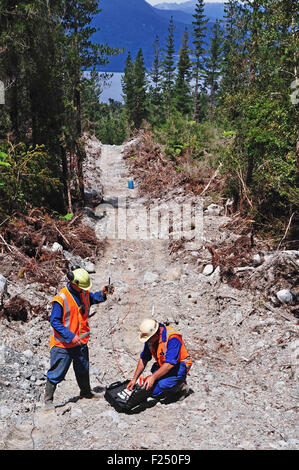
[50,283,107,343]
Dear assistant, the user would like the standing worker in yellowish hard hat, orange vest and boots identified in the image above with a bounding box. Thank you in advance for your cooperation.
[45,268,114,411]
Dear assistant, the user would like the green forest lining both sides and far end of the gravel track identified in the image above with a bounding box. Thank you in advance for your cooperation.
[0,0,299,246]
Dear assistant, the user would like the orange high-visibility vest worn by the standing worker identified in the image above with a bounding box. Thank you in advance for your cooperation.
[50,287,90,348]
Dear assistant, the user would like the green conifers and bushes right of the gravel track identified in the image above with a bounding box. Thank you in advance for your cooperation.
[119,0,299,241]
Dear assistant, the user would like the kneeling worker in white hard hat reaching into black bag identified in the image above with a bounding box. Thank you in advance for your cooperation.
[127,319,192,399]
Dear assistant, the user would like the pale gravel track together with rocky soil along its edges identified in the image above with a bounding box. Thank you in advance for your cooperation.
[0,134,299,450]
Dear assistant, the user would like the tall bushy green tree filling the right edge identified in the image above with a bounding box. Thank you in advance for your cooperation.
[221,0,299,229]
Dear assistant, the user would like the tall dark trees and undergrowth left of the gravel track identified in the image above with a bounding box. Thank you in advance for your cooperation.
[0,0,118,216]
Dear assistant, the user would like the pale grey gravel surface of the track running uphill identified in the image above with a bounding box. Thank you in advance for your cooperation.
[0,142,299,450]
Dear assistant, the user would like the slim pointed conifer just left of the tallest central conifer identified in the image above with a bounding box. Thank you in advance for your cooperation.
[175,28,192,115]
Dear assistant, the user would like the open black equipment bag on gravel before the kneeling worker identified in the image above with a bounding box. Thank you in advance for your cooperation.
[104,380,150,413]
